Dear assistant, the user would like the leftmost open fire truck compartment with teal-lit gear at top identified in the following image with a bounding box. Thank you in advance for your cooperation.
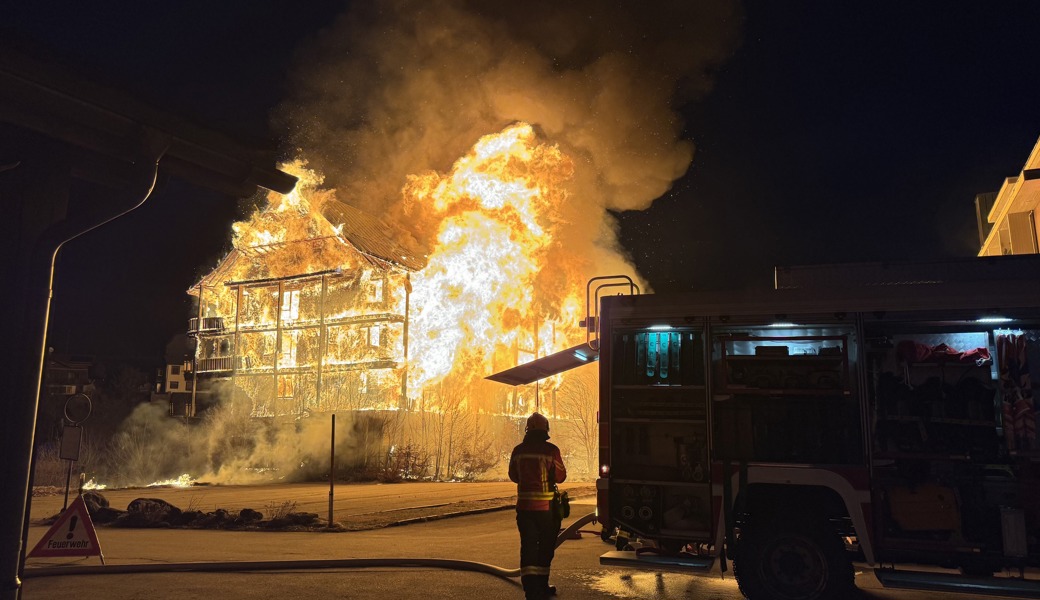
[609,328,711,546]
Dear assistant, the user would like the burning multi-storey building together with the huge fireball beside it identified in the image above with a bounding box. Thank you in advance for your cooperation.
[175,123,600,477]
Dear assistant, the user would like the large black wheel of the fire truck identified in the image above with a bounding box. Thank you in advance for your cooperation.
[733,519,855,600]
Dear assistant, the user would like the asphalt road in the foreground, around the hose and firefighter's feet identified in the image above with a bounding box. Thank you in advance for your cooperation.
[23,490,998,600]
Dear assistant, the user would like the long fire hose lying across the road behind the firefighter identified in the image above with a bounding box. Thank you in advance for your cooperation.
[23,513,596,580]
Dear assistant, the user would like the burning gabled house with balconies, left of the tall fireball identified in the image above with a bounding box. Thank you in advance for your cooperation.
[188,200,424,417]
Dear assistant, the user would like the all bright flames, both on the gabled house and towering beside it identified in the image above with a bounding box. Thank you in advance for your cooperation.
[197,123,590,414]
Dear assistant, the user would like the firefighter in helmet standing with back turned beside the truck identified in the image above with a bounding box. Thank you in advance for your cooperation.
[510,413,567,600]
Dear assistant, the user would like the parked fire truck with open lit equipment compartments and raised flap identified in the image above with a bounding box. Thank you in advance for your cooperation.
[490,257,1040,600]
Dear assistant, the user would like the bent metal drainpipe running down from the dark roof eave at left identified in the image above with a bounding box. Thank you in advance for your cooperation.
[0,138,171,600]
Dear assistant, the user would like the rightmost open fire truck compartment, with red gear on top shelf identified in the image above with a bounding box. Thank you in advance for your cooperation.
[867,331,1040,557]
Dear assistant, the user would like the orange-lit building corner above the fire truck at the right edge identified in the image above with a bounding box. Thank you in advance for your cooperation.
[976,134,1040,256]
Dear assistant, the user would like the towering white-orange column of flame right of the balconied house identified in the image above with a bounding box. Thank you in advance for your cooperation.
[405,124,580,393]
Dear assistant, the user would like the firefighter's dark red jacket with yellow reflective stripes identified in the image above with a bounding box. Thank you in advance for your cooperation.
[510,434,567,511]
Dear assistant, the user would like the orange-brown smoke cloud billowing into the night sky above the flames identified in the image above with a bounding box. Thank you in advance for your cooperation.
[277,0,742,266]
